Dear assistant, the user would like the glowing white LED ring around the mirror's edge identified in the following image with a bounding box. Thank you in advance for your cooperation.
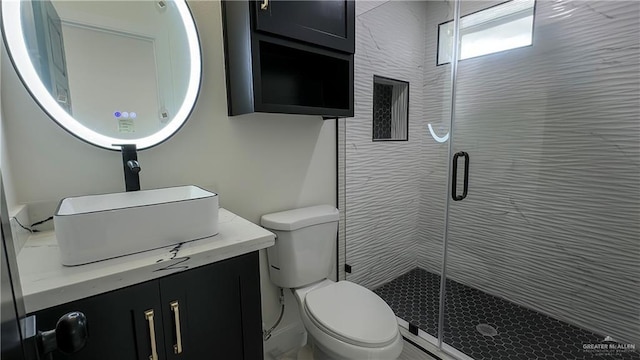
[2,0,202,151]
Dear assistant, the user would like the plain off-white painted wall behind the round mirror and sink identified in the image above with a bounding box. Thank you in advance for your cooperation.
[2,1,336,338]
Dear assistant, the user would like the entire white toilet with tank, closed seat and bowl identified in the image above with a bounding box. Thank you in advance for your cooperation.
[261,205,403,360]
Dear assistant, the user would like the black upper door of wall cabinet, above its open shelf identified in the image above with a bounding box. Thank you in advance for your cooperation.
[253,0,355,54]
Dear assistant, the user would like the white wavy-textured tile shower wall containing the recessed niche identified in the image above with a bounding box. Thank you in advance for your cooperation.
[345,1,425,287]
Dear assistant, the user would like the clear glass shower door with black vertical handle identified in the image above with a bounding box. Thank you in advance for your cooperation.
[438,0,640,360]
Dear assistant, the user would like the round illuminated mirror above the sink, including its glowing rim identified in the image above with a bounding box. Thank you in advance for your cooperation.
[2,0,201,150]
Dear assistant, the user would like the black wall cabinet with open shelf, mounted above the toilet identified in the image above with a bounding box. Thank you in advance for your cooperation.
[222,0,355,117]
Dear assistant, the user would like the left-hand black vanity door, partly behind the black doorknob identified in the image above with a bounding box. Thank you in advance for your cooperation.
[35,281,165,360]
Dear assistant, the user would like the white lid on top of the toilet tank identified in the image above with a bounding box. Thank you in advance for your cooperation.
[260,205,339,231]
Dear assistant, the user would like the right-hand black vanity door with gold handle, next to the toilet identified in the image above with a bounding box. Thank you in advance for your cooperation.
[160,252,263,360]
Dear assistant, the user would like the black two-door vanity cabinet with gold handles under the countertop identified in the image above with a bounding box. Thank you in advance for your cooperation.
[35,252,263,360]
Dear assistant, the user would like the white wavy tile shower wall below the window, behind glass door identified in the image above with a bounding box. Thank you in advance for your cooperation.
[416,1,640,344]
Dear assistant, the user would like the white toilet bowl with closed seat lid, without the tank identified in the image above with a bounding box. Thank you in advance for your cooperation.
[294,280,403,360]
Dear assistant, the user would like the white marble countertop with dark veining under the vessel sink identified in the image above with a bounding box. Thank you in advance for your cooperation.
[18,209,275,313]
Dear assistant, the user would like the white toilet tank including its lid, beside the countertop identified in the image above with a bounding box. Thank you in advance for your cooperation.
[260,205,338,288]
